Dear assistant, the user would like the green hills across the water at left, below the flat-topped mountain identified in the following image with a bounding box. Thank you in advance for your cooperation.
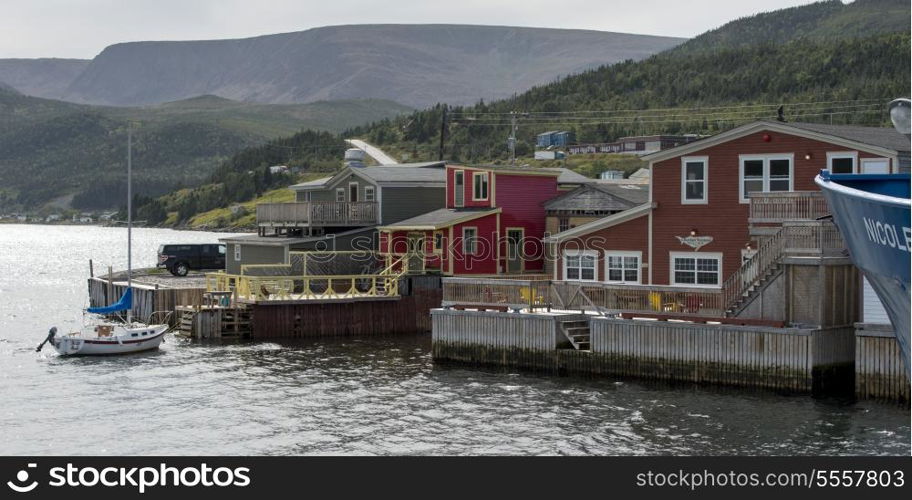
[0,88,410,210]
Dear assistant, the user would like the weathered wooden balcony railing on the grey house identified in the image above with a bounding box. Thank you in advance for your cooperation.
[257,201,379,227]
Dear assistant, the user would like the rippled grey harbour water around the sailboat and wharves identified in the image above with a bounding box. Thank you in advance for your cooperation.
[0,225,910,455]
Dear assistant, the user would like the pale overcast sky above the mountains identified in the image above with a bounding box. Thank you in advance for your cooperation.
[0,0,824,59]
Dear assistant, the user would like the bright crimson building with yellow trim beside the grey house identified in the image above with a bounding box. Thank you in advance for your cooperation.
[379,165,568,276]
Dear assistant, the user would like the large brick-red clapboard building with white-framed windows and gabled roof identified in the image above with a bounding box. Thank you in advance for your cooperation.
[548,121,909,287]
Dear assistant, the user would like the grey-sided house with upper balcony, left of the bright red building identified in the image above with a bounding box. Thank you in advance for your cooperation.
[221,162,446,274]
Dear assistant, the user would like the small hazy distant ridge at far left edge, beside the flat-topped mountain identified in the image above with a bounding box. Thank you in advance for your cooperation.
[0,59,91,97]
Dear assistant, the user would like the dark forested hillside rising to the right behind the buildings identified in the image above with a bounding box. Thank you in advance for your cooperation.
[351,0,910,161]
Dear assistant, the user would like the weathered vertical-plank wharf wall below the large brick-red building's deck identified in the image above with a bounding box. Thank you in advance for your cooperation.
[431,309,854,393]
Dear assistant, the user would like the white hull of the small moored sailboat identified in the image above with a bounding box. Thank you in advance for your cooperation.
[53,325,168,356]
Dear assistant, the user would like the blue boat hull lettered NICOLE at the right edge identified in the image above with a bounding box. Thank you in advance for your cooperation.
[815,172,912,367]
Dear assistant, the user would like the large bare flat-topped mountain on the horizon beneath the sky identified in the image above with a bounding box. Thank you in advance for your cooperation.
[14,25,684,107]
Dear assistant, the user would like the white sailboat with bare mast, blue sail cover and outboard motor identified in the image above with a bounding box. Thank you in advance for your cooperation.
[36,130,168,356]
